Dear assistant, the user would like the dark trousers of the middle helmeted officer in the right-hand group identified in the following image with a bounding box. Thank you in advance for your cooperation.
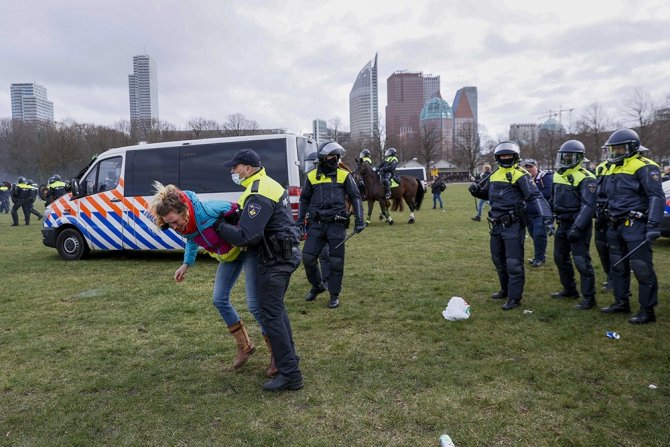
[554,219,596,299]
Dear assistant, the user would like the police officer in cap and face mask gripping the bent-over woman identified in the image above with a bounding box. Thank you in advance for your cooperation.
[216,149,303,391]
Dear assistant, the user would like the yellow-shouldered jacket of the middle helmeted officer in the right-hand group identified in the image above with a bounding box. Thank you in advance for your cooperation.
[553,166,596,230]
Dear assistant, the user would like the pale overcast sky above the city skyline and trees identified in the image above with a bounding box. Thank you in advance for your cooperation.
[0,0,670,137]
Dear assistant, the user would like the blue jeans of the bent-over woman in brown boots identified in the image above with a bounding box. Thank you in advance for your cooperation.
[213,251,265,334]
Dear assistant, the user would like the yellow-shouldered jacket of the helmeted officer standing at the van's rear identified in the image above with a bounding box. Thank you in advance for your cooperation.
[298,166,362,222]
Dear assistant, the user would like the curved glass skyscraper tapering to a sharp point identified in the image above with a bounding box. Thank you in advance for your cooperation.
[349,54,379,142]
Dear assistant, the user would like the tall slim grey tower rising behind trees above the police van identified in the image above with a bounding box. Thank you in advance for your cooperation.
[128,54,158,135]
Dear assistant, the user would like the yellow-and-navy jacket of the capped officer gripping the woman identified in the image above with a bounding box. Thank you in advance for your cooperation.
[217,168,298,250]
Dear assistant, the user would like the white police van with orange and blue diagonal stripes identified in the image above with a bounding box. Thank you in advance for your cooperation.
[42,134,317,260]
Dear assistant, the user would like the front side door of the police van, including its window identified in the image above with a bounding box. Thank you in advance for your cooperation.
[74,156,128,250]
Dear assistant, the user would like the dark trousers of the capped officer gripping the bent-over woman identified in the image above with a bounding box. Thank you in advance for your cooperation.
[256,246,301,377]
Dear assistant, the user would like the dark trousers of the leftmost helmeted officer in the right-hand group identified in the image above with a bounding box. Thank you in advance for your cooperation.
[490,222,526,300]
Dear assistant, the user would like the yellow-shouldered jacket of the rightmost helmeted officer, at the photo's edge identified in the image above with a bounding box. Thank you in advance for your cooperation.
[604,153,665,226]
